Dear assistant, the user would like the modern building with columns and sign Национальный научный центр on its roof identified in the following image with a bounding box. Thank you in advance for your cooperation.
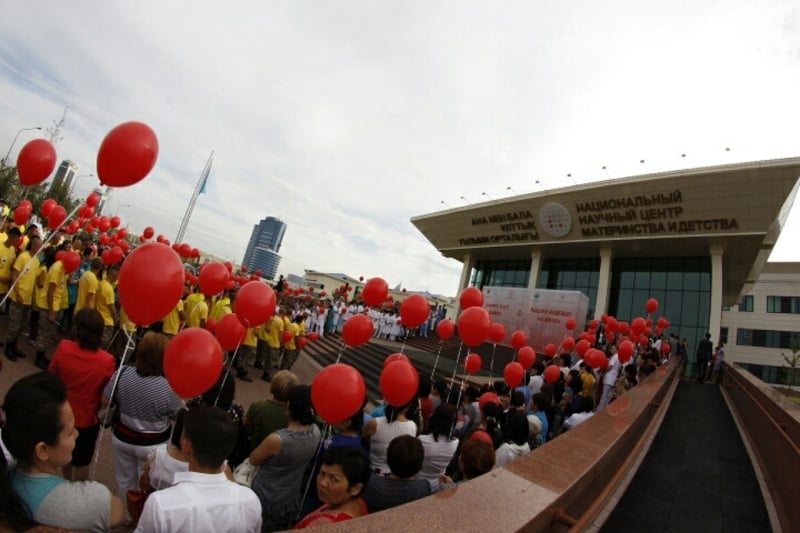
[411,158,800,374]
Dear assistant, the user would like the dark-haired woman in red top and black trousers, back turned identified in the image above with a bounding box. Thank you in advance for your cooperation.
[48,309,114,481]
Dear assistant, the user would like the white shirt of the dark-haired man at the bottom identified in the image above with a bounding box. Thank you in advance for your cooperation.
[136,472,261,533]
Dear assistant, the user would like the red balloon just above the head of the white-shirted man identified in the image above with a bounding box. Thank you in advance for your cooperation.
[164,328,222,398]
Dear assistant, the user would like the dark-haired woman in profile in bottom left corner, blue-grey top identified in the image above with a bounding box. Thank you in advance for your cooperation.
[0,372,123,531]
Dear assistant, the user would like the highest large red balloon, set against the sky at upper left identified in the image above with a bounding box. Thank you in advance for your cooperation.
[97,122,158,187]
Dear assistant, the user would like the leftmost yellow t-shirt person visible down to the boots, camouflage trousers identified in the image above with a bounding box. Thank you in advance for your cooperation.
[5,236,42,361]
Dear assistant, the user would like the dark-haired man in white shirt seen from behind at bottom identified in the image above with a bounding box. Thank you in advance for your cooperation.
[136,406,261,533]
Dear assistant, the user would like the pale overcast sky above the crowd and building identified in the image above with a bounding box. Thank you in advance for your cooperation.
[0,0,800,295]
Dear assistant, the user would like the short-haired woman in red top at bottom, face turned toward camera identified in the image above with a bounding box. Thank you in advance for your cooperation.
[297,446,370,529]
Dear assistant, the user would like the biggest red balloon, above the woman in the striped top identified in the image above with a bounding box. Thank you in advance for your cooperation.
[118,243,184,326]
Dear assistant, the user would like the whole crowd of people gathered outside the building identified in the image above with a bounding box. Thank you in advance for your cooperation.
[0,221,685,532]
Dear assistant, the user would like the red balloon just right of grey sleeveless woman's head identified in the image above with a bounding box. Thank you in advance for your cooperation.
[311,363,367,424]
